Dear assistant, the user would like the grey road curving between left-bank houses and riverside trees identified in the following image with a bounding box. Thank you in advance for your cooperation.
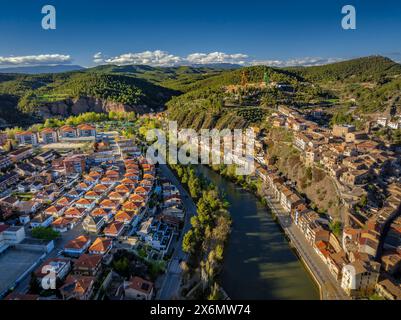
[157,165,196,300]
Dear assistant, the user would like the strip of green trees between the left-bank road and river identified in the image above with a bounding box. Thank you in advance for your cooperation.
[171,165,231,300]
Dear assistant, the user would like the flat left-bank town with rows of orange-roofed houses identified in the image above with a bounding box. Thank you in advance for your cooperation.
[0,121,186,300]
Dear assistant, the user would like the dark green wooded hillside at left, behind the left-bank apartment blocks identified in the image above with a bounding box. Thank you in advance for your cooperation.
[0,70,179,121]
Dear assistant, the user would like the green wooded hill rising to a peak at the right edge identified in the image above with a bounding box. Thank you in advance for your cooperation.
[287,56,401,116]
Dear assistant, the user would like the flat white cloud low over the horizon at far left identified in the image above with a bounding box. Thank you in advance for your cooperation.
[0,54,72,65]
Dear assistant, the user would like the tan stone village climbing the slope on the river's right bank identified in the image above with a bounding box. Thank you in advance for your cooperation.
[250,106,401,299]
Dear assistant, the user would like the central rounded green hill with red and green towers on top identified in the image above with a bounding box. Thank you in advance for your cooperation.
[167,66,333,129]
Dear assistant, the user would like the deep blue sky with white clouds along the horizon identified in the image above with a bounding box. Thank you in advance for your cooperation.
[0,0,401,67]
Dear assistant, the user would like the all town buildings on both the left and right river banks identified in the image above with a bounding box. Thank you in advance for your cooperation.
[0,106,401,300]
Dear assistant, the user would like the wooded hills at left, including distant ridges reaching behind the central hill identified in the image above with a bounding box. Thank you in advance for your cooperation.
[0,65,237,125]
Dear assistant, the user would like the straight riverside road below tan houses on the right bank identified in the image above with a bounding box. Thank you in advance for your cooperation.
[265,192,349,300]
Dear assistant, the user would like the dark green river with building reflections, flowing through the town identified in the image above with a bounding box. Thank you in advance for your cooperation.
[198,166,319,300]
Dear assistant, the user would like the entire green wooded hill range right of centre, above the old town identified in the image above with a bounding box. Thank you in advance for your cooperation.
[168,56,401,128]
